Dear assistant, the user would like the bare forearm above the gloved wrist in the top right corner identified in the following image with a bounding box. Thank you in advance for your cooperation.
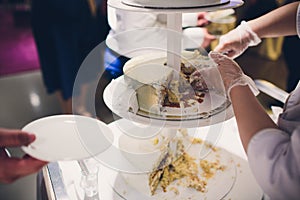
[248,2,299,38]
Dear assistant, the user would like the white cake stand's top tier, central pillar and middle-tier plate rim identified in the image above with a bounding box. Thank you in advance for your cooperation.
[103,0,243,128]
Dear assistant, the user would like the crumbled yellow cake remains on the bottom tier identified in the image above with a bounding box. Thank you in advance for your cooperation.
[148,133,226,195]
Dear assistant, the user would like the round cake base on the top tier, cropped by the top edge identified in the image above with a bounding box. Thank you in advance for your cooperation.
[122,0,230,9]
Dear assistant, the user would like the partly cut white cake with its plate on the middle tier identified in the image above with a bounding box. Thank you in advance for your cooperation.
[103,51,233,128]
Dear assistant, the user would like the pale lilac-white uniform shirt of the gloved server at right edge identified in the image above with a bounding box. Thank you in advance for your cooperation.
[247,4,300,200]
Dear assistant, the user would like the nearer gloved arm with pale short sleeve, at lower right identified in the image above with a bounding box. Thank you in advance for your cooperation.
[209,52,300,199]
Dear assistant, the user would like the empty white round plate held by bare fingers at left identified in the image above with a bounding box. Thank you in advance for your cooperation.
[22,115,113,162]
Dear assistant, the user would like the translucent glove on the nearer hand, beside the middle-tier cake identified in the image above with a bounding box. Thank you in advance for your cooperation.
[208,52,259,99]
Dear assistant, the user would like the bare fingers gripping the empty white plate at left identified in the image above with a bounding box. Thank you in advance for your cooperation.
[0,128,47,183]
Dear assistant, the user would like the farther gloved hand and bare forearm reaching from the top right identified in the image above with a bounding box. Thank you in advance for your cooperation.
[214,2,299,58]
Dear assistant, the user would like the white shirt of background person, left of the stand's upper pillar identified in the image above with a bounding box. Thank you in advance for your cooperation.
[106,7,167,57]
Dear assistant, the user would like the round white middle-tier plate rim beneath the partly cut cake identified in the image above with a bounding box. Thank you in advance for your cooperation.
[103,76,234,128]
